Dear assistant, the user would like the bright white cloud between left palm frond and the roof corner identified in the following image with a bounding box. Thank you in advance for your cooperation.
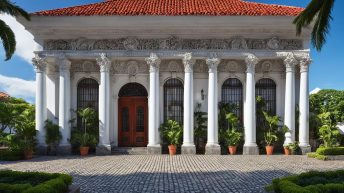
[0,14,41,64]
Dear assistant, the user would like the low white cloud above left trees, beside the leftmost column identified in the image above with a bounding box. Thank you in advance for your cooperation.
[0,74,36,103]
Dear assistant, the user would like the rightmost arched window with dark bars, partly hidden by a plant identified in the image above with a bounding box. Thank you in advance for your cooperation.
[256,78,276,115]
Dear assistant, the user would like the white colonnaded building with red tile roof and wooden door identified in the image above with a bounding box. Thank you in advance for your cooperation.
[21,0,311,154]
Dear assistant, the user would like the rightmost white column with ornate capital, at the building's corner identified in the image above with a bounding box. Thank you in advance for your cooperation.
[299,56,311,154]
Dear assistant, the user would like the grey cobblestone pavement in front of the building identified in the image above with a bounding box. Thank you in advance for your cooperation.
[0,155,344,193]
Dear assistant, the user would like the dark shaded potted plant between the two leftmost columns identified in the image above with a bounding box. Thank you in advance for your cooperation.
[45,120,62,155]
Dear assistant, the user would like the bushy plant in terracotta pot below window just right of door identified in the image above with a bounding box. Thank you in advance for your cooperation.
[162,120,183,155]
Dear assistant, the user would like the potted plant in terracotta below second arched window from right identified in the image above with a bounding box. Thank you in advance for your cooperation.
[221,113,242,155]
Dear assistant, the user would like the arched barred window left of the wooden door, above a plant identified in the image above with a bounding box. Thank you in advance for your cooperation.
[77,78,99,111]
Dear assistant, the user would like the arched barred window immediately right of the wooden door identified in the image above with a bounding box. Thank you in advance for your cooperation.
[164,78,184,123]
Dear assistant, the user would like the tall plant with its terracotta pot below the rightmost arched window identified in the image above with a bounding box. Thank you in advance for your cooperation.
[263,112,280,155]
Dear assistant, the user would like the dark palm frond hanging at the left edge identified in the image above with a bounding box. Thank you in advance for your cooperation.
[0,20,16,61]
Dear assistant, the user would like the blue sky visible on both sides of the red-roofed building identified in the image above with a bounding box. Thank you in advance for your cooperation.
[0,0,344,102]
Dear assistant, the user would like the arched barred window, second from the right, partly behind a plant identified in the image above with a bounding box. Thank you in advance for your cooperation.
[221,78,243,118]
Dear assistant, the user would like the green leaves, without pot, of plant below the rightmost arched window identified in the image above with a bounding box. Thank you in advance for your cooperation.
[263,111,280,145]
